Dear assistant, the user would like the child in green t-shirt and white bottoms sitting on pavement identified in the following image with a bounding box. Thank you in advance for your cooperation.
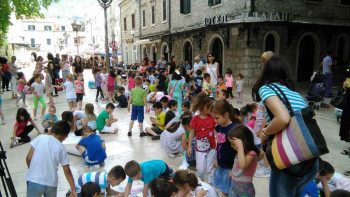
[96,103,118,133]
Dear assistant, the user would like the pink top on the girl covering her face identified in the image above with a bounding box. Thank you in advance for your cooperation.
[232,150,258,184]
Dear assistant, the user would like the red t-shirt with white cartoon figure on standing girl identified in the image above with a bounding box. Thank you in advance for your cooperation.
[190,115,216,152]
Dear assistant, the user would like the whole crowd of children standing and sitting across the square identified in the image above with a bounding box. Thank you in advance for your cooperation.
[0,56,348,197]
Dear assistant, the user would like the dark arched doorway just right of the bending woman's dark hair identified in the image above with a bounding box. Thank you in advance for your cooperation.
[297,35,315,82]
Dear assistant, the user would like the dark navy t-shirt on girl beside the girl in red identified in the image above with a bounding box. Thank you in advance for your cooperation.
[215,123,237,169]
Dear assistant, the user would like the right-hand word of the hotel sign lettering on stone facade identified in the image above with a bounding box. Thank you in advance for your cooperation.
[242,12,293,22]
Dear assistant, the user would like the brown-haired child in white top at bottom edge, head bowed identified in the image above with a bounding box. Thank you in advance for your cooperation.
[173,170,219,197]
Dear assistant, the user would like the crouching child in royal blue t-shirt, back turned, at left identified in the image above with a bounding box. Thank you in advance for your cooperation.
[76,127,107,167]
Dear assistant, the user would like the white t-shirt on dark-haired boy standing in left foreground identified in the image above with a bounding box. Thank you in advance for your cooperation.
[25,135,69,187]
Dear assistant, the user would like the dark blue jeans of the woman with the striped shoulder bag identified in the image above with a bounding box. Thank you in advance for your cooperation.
[270,159,319,197]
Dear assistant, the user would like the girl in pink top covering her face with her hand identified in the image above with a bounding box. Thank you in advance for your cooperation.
[228,125,260,197]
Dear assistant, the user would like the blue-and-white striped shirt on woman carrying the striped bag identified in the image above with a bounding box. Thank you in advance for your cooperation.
[259,83,306,122]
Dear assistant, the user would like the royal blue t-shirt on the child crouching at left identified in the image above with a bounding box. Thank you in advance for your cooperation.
[78,134,107,162]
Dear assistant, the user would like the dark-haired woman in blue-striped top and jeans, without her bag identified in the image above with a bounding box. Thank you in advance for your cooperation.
[252,56,318,197]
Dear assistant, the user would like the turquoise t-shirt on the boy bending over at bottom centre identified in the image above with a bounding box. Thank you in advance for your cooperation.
[128,160,166,184]
